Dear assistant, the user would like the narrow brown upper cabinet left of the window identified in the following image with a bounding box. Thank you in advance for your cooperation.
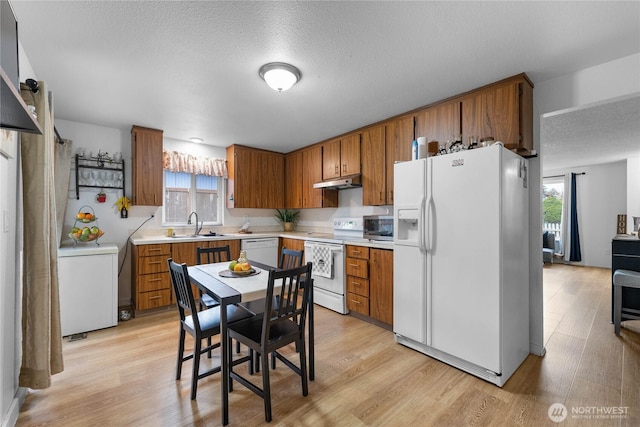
[131,126,163,206]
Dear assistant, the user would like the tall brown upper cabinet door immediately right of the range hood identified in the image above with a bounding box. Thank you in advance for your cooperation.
[362,125,387,206]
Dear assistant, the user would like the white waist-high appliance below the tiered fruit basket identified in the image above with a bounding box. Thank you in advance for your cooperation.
[58,243,118,337]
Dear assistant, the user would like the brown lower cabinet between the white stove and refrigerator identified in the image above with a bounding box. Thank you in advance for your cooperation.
[345,245,393,326]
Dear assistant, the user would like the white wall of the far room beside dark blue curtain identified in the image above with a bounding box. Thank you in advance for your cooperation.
[549,161,627,268]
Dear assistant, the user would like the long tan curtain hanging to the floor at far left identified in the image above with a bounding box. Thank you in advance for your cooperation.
[19,82,66,389]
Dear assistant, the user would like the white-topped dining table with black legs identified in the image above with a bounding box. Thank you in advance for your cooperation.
[187,261,315,425]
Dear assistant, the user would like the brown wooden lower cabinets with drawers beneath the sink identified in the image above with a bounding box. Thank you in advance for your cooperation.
[131,240,240,312]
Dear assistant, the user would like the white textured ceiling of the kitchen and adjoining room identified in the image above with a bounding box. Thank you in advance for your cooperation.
[11,0,640,172]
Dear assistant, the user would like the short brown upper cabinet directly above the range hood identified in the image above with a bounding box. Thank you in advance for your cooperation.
[322,133,360,181]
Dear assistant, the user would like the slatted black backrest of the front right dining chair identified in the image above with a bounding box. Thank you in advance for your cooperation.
[262,262,312,343]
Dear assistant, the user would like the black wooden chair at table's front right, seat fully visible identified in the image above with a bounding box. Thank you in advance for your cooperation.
[228,263,311,422]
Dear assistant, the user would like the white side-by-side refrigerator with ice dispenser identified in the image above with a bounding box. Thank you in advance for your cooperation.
[393,145,529,386]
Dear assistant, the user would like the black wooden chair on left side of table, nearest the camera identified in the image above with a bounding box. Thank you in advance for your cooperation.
[167,258,253,400]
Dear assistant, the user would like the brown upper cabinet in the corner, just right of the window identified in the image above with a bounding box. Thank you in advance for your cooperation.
[227,145,284,209]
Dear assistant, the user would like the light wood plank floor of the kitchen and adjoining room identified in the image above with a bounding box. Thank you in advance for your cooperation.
[17,264,640,427]
